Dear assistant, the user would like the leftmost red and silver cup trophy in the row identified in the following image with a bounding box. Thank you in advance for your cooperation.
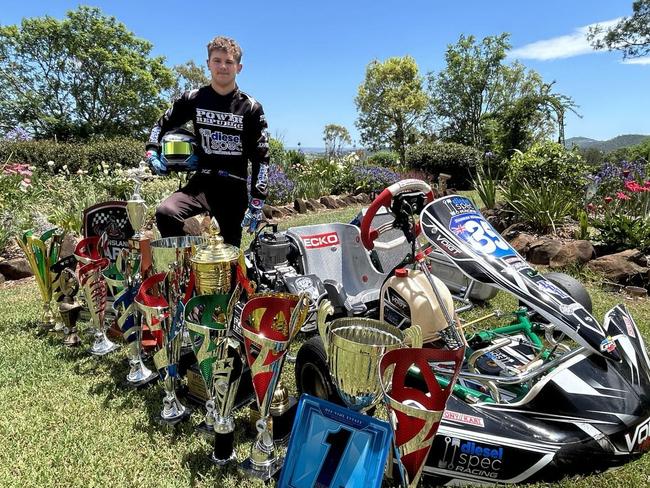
[74,236,117,356]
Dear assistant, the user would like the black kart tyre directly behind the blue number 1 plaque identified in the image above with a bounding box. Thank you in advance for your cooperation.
[295,336,344,405]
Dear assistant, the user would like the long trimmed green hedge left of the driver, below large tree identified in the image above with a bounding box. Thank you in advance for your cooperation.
[0,137,145,173]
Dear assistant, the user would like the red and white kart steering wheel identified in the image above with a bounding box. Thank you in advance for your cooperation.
[361,178,433,251]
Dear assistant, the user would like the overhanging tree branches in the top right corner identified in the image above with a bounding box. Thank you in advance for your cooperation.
[587,0,650,59]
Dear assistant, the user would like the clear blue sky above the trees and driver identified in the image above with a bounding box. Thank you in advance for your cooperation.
[0,0,650,147]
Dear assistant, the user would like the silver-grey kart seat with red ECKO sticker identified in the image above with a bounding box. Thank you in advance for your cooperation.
[287,222,386,314]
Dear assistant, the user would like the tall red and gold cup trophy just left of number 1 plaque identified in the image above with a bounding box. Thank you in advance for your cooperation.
[241,294,309,480]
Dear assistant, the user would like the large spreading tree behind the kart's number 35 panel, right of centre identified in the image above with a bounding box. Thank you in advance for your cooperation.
[428,33,574,155]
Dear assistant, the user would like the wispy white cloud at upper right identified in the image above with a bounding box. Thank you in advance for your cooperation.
[508,17,621,61]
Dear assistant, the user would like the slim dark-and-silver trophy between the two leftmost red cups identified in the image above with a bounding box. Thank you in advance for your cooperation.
[104,249,158,387]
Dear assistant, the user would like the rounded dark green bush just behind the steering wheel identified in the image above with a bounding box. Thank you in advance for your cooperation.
[406,142,482,190]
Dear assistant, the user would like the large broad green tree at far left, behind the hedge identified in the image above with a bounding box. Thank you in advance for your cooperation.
[0,6,173,140]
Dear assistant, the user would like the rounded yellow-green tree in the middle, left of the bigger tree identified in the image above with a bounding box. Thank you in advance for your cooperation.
[355,56,428,163]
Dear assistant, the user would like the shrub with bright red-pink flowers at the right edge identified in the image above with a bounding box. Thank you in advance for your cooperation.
[587,161,650,252]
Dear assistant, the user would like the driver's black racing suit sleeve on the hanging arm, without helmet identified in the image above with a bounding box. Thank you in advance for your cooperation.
[246,102,269,200]
